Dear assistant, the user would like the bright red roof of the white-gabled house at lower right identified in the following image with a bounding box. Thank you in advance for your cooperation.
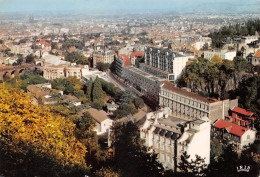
[213,119,248,136]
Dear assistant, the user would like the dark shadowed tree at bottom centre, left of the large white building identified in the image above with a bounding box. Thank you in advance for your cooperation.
[112,122,164,177]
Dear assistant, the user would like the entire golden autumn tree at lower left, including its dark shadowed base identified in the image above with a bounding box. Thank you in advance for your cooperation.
[0,86,88,177]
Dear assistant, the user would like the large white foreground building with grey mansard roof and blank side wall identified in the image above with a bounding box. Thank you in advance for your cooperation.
[140,108,211,171]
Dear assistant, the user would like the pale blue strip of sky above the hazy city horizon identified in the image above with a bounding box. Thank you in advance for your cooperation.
[0,0,260,12]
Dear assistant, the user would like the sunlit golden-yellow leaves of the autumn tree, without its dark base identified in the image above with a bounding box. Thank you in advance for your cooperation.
[0,89,86,167]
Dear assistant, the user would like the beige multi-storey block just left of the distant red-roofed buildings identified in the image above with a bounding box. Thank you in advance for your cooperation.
[93,49,115,67]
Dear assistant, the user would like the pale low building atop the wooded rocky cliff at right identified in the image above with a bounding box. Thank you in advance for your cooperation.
[204,50,236,60]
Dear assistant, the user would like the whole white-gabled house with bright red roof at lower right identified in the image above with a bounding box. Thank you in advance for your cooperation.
[212,119,256,150]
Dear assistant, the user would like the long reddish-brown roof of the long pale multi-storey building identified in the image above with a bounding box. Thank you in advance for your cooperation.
[163,81,218,103]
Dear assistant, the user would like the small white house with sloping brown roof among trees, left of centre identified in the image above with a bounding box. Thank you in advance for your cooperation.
[88,108,113,135]
